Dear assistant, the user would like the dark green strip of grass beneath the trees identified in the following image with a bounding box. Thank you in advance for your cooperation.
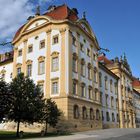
[0,131,71,140]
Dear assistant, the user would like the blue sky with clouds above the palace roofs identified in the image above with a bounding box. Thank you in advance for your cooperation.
[0,0,140,77]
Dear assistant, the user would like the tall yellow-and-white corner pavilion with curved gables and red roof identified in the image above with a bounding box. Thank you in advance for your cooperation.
[12,5,102,130]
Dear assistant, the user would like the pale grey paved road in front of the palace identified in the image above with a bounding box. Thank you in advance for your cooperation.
[26,128,140,140]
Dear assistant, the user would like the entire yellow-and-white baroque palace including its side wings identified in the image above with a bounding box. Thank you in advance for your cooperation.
[0,5,136,131]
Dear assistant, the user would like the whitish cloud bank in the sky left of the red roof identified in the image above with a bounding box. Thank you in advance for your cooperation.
[0,0,53,42]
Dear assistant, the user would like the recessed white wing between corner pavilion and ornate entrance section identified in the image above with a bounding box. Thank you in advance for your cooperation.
[99,63,119,128]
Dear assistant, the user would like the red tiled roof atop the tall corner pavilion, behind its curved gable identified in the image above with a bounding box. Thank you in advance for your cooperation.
[13,4,78,40]
